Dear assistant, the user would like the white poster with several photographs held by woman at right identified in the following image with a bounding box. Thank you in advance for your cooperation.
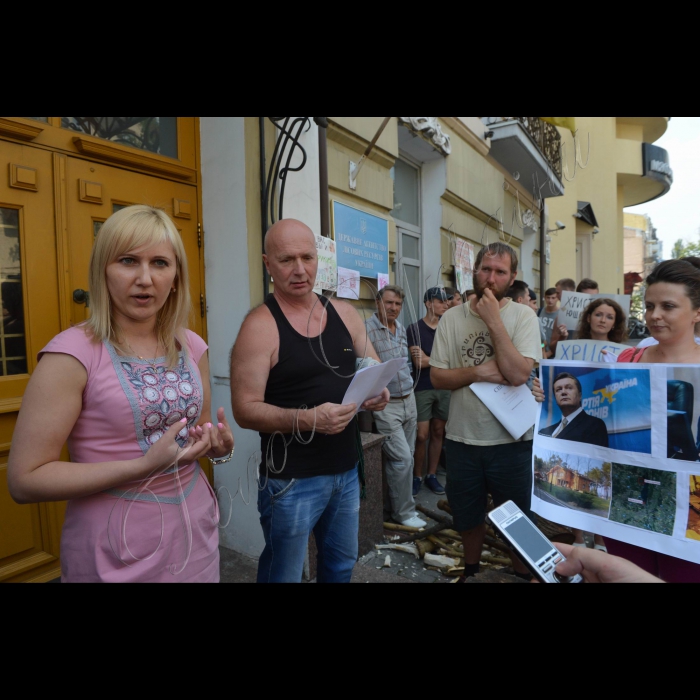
[533,360,700,564]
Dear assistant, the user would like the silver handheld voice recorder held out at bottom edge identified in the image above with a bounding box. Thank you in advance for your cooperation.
[489,501,583,584]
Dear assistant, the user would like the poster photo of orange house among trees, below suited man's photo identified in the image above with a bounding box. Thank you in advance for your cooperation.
[535,450,612,519]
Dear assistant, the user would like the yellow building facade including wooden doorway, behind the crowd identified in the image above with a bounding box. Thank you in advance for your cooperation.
[0,117,668,582]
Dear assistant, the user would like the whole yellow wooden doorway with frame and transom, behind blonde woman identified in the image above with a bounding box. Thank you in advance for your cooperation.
[0,117,206,582]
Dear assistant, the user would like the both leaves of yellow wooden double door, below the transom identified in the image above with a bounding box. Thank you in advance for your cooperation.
[0,139,212,583]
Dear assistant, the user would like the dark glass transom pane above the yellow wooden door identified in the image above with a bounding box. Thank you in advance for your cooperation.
[61,117,178,158]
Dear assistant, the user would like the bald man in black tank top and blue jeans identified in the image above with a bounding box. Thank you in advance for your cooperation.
[231,219,389,583]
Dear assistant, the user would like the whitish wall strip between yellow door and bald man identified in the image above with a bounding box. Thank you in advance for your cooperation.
[200,117,264,556]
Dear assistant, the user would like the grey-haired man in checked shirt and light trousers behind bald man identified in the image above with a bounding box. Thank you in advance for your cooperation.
[367,285,426,528]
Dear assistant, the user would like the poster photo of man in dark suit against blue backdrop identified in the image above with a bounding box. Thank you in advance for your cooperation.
[538,363,652,455]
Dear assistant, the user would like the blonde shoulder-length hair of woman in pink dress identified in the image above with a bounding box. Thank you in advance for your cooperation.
[86,206,192,367]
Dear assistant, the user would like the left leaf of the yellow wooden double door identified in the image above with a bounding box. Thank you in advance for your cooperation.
[0,142,64,581]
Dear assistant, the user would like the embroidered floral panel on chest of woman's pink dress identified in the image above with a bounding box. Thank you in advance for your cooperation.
[108,345,203,454]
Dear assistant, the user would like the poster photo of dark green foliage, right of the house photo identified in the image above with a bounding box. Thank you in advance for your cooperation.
[610,464,678,537]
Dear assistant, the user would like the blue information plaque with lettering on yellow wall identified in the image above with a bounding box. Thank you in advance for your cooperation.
[333,202,389,279]
